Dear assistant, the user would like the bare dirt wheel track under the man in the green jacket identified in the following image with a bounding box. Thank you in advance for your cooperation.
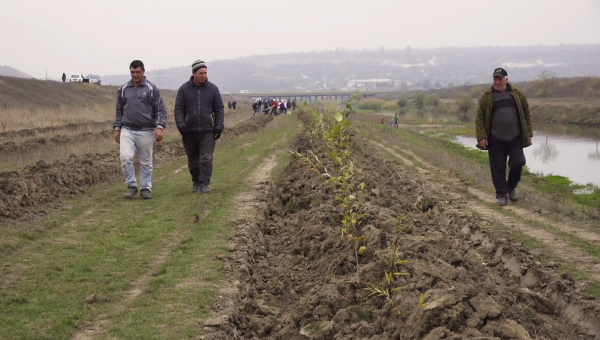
[371,135,600,281]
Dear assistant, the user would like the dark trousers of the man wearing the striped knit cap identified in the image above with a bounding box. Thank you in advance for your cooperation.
[183,132,215,185]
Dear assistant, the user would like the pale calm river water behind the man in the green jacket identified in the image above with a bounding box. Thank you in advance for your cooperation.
[456,123,600,186]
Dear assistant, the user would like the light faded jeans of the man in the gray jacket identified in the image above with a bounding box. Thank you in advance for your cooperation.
[120,128,155,190]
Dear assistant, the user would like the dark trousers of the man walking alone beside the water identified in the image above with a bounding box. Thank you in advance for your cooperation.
[488,136,525,197]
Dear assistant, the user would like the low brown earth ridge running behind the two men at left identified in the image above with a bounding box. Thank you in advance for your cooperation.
[0,116,273,220]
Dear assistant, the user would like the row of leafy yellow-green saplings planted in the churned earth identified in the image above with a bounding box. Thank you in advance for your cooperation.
[294,99,426,314]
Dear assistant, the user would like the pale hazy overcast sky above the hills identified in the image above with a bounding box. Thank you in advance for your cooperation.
[0,0,600,78]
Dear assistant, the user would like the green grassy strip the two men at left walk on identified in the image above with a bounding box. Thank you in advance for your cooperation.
[0,116,297,340]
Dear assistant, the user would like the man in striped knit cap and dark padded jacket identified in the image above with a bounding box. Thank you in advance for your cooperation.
[175,60,225,194]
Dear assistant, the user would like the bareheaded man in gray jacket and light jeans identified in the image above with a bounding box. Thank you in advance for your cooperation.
[113,60,167,199]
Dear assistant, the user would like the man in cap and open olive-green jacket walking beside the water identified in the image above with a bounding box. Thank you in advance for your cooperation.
[475,68,533,206]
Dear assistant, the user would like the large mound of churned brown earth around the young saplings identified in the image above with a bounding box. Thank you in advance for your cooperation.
[204,115,600,340]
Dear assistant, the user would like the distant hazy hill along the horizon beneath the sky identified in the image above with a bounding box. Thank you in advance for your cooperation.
[102,45,600,92]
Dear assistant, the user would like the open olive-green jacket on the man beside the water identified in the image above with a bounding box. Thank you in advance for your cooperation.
[475,84,533,148]
